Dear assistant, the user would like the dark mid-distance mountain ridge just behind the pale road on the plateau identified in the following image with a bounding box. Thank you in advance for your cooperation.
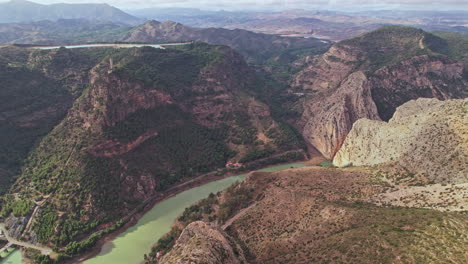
[0,19,330,64]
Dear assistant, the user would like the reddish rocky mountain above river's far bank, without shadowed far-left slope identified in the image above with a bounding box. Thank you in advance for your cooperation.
[4,43,308,244]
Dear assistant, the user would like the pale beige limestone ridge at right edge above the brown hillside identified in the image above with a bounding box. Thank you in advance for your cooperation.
[333,99,468,183]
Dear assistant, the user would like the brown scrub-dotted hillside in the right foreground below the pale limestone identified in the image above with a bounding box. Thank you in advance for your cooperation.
[204,167,468,264]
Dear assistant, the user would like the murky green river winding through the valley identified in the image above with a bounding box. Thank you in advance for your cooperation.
[1,163,305,264]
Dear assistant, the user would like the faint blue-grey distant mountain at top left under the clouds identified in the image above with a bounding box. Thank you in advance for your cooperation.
[0,0,141,25]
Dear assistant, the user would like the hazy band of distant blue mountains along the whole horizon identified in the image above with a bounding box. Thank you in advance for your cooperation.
[0,0,468,42]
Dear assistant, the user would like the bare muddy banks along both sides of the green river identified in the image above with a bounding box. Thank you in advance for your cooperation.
[65,162,305,264]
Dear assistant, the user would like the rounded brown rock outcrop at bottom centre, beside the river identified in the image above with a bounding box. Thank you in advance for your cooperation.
[158,221,247,264]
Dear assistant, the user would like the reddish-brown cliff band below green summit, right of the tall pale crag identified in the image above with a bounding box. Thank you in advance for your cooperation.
[367,55,468,120]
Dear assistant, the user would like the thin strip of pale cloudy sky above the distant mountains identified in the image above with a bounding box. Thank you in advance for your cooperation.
[5,0,468,11]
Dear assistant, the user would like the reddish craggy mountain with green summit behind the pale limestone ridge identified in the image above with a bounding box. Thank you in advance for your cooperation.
[292,26,468,159]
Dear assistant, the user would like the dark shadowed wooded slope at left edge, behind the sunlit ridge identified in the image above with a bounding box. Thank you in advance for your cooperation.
[0,49,70,192]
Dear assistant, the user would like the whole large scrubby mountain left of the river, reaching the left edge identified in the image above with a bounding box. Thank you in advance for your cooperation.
[0,43,304,256]
